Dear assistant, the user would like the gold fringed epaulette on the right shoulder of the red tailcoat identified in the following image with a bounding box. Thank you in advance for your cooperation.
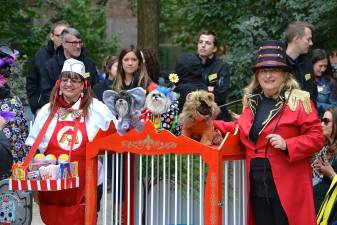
[285,89,312,114]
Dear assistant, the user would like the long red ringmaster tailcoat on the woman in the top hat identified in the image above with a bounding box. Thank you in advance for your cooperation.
[214,98,324,225]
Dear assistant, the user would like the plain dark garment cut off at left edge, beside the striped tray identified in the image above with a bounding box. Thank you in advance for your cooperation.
[0,130,13,180]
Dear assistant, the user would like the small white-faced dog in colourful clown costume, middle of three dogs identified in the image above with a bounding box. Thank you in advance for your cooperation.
[145,86,181,135]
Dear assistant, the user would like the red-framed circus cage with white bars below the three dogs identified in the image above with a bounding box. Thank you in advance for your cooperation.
[86,123,246,225]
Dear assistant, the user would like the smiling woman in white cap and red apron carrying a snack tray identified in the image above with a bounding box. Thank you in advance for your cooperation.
[26,58,116,225]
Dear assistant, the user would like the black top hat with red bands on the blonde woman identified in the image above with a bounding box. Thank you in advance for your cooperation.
[253,40,291,72]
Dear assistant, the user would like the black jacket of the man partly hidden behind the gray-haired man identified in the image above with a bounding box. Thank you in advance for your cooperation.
[26,41,55,114]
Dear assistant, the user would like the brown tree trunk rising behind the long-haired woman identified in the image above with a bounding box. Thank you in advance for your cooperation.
[137,0,160,53]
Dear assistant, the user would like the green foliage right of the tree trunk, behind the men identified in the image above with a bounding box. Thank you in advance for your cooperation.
[161,0,337,101]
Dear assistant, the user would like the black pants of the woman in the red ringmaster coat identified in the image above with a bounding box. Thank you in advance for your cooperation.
[252,196,289,225]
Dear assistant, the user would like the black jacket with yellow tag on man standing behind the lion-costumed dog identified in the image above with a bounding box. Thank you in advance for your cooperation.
[202,56,230,121]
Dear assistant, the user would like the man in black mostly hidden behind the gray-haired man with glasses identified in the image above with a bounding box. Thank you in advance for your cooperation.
[26,20,69,114]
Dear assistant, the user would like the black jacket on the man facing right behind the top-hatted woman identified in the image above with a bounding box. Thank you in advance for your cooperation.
[286,55,318,104]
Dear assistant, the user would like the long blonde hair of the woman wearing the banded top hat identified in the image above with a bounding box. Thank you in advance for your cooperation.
[242,70,300,107]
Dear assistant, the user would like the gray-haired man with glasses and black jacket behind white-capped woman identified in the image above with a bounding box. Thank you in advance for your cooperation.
[41,27,98,108]
